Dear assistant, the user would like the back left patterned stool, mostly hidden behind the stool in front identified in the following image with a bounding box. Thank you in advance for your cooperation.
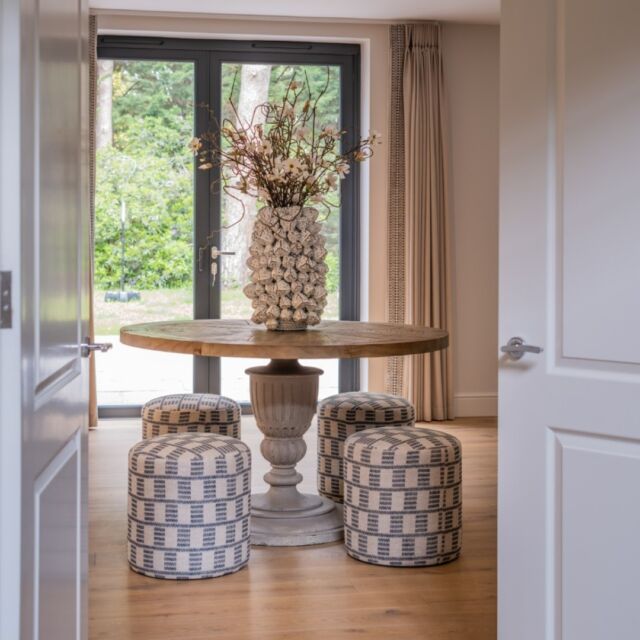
[142,393,240,440]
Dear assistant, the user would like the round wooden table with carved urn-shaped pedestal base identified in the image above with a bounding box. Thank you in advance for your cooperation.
[120,320,449,546]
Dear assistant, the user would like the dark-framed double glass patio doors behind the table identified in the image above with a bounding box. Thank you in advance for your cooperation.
[94,36,359,415]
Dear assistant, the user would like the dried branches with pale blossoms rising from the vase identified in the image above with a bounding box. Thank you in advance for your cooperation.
[190,75,380,216]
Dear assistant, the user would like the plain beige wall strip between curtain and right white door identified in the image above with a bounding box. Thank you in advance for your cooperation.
[443,24,499,416]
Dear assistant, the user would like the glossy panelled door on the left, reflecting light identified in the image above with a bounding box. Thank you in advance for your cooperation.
[18,0,88,640]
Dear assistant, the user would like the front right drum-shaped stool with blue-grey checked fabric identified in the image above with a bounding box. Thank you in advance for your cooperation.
[344,427,462,567]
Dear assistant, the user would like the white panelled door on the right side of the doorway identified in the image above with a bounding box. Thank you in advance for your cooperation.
[498,0,640,640]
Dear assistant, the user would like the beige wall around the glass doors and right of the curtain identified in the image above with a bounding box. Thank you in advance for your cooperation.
[98,13,498,415]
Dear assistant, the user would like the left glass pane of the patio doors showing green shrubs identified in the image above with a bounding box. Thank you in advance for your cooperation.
[93,57,195,416]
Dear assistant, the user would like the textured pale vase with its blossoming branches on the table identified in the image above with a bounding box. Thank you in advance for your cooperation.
[190,74,380,330]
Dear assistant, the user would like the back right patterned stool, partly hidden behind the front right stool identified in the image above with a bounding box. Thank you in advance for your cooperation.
[318,391,415,502]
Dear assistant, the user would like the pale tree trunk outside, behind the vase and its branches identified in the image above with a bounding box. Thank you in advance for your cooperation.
[220,64,271,287]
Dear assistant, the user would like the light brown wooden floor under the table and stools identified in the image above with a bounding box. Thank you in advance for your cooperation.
[89,417,496,640]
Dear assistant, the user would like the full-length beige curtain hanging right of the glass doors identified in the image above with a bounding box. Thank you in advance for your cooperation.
[387,23,453,421]
